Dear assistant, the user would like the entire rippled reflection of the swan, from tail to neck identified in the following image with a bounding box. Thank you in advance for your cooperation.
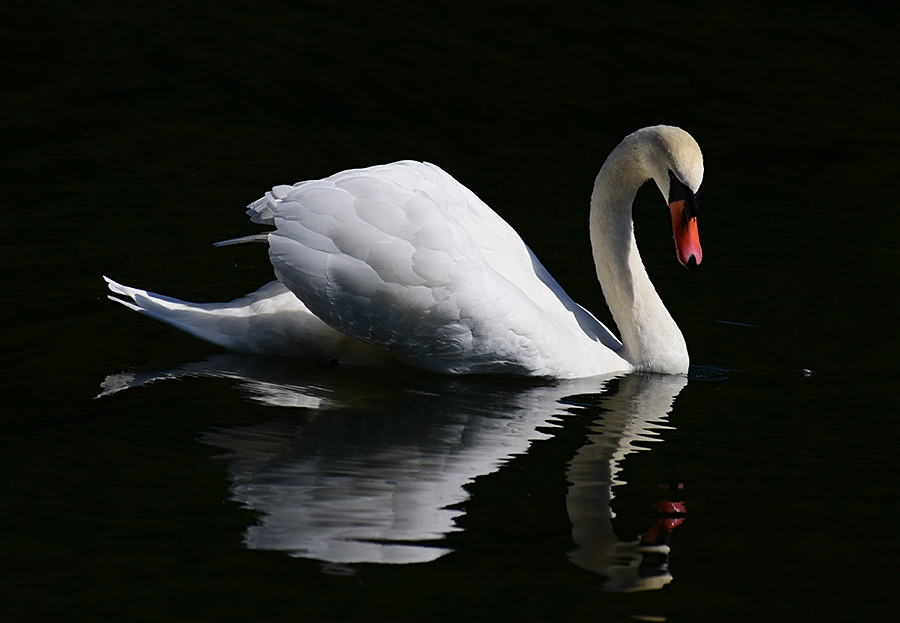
[104,355,687,590]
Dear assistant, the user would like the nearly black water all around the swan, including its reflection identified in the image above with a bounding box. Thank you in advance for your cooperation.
[0,1,900,621]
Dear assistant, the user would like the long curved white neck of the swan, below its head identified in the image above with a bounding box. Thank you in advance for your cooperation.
[590,135,688,374]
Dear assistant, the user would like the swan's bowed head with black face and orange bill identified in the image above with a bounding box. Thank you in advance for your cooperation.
[639,125,703,268]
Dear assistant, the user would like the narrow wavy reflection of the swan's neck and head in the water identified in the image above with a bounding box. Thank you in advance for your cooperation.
[566,374,687,592]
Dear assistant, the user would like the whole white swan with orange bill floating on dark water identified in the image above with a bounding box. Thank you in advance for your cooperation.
[104,125,703,378]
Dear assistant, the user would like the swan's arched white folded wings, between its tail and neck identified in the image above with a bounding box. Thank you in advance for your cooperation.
[248,162,623,376]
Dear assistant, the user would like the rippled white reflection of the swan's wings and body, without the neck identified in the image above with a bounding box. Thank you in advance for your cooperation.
[203,366,612,563]
